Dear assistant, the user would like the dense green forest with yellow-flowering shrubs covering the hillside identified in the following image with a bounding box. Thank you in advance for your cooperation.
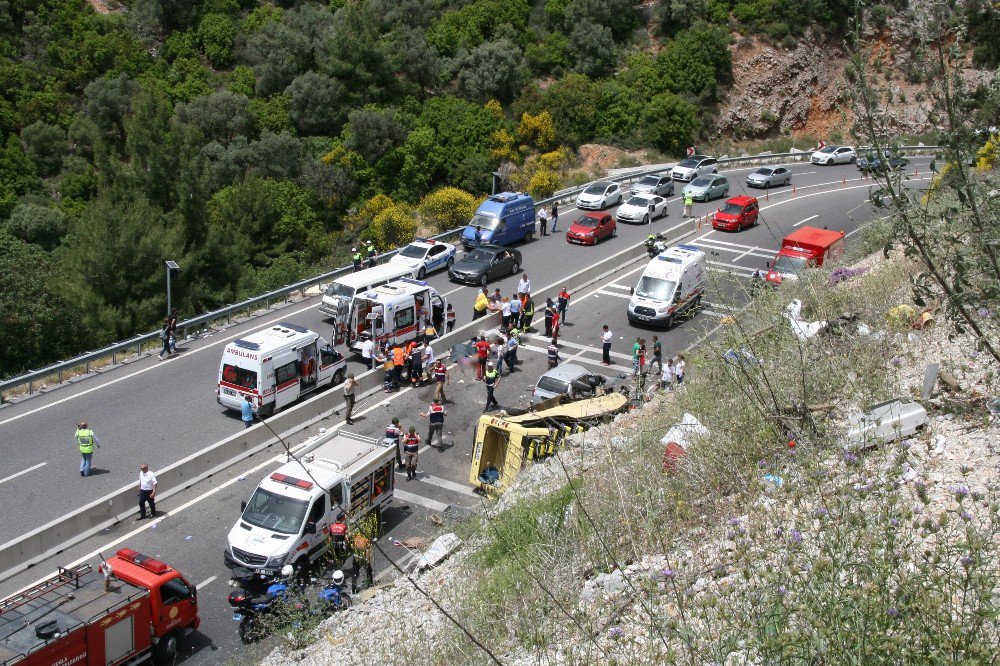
[0,0,996,376]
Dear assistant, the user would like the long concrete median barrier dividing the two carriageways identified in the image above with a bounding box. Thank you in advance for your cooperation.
[0,220,695,580]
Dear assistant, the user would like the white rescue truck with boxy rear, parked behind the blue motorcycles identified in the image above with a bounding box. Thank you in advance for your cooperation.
[225,430,396,575]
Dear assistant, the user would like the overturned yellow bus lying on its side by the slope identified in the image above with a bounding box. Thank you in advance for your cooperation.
[469,393,628,494]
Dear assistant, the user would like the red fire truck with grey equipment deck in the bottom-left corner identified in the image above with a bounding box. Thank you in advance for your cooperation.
[0,548,200,666]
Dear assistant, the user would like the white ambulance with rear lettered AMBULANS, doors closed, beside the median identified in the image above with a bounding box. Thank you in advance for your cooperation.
[216,321,347,416]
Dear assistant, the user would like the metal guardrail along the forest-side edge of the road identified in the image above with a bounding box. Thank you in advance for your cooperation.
[0,146,941,404]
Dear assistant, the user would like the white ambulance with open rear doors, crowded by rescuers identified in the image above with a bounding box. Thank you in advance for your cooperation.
[334,278,447,352]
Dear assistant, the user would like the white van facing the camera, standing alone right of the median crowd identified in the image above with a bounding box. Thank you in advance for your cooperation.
[628,245,707,328]
